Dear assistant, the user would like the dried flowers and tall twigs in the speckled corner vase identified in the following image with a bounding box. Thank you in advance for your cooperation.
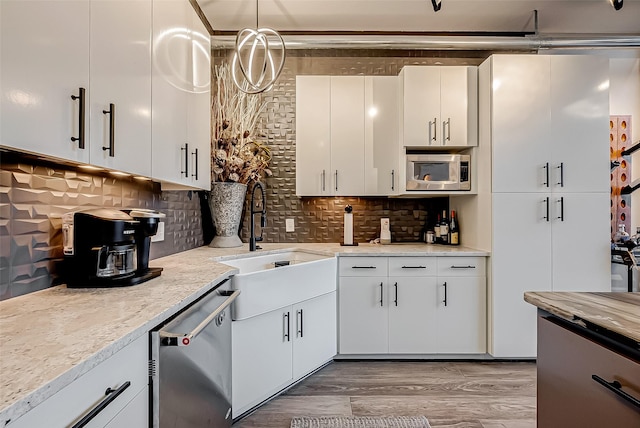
[212,64,271,184]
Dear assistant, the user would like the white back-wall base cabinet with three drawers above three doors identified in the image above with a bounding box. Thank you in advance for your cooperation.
[339,257,486,355]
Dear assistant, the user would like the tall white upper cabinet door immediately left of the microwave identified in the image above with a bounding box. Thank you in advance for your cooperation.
[364,76,400,196]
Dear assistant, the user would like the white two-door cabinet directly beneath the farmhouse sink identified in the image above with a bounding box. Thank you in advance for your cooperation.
[232,291,336,418]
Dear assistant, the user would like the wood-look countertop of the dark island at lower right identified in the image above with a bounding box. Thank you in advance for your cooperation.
[524,291,640,343]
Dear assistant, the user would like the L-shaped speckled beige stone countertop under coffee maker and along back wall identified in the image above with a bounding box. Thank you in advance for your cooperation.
[0,243,489,426]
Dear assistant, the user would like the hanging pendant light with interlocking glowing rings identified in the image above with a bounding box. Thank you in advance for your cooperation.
[231,0,286,94]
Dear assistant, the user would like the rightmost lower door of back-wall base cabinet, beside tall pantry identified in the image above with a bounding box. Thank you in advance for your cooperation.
[436,276,487,354]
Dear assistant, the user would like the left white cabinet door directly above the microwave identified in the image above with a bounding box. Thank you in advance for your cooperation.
[400,66,442,147]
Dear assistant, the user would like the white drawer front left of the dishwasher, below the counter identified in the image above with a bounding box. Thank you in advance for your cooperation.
[9,335,149,428]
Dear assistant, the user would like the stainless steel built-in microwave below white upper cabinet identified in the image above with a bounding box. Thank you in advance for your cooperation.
[406,154,471,191]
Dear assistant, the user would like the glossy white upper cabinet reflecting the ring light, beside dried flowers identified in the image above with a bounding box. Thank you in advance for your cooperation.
[151,0,211,189]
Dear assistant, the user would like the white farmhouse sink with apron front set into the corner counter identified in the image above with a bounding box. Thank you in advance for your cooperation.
[220,251,337,320]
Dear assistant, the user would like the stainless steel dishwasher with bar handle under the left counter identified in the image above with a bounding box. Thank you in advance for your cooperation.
[150,280,240,428]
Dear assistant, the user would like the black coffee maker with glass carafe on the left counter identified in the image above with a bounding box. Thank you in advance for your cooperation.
[62,208,164,288]
